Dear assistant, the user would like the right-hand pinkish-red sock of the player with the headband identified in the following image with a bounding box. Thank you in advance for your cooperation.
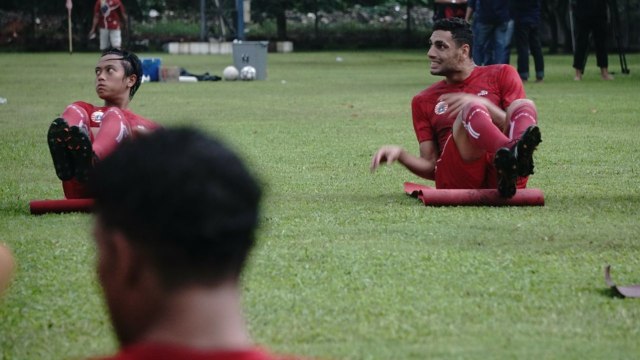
[93,108,131,159]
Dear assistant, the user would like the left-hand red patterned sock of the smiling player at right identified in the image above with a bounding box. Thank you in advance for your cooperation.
[462,104,509,153]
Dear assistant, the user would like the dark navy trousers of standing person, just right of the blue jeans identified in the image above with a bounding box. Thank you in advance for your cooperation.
[514,23,544,80]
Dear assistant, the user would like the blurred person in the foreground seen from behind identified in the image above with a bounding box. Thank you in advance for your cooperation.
[90,129,290,360]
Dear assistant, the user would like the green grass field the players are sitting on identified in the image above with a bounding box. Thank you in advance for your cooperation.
[0,51,640,359]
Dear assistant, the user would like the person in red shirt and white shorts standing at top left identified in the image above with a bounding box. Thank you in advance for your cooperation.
[89,0,127,51]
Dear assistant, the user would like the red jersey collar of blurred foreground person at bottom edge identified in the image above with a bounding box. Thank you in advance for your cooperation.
[95,343,292,360]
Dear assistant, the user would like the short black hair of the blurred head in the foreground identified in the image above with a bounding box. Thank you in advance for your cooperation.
[90,128,261,288]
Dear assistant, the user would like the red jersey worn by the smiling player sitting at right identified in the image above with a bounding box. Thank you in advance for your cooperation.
[411,65,526,152]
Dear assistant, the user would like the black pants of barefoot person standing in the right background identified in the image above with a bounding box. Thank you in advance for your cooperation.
[573,14,609,73]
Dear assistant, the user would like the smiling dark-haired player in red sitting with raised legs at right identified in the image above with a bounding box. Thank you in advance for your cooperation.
[371,18,542,197]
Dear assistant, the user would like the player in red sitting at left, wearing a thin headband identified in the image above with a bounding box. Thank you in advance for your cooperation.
[47,48,159,199]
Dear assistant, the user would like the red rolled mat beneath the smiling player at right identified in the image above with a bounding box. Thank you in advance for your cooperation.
[404,182,544,206]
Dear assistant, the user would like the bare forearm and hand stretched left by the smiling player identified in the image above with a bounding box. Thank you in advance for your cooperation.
[371,141,438,180]
